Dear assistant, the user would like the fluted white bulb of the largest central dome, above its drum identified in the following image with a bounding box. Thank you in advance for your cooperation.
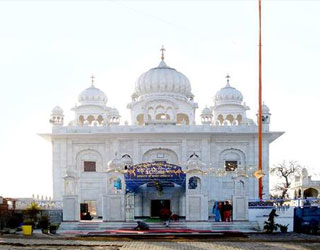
[135,61,192,97]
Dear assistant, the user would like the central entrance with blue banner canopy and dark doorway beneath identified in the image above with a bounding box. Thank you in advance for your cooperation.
[125,162,186,218]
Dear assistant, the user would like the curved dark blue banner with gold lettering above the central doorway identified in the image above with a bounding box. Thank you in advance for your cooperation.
[125,162,186,192]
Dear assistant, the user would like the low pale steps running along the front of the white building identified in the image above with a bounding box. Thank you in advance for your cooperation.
[59,221,261,233]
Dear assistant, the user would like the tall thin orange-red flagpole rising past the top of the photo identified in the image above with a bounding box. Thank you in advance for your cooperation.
[258,0,263,200]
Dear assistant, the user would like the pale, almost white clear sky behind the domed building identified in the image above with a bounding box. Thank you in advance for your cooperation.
[0,0,320,197]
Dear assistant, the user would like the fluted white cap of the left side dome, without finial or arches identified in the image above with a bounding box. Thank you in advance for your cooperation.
[78,85,108,106]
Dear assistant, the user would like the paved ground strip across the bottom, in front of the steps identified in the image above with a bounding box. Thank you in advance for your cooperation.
[0,234,320,250]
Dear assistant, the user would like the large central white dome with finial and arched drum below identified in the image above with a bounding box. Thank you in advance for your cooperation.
[128,47,198,125]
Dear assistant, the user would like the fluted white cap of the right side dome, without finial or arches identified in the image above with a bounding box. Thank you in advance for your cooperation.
[214,82,243,105]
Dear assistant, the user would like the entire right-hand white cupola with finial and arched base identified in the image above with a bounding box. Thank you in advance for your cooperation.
[212,75,249,126]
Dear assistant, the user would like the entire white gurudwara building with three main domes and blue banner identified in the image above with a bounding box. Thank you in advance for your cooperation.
[42,51,283,221]
